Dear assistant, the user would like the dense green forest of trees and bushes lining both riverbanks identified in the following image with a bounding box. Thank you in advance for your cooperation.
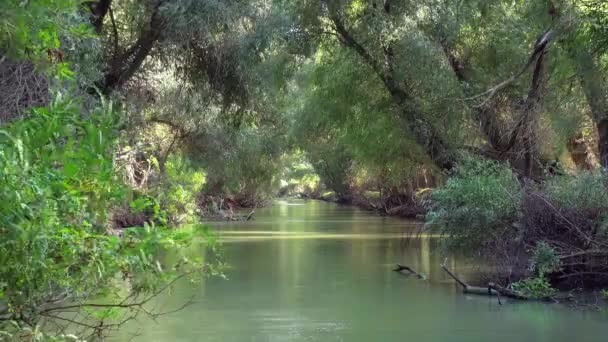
[0,0,608,341]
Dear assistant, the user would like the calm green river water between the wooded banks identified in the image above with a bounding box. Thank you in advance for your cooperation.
[115,201,608,342]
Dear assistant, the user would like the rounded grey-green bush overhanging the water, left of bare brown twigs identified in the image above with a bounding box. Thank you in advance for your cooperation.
[426,156,523,253]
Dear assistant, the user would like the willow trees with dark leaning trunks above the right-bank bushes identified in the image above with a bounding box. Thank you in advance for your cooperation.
[278,0,603,177]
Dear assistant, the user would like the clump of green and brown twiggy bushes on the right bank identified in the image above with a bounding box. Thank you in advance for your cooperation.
[427,162,608,290]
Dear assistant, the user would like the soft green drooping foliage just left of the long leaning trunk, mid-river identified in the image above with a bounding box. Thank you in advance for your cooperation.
[286,42,428,194]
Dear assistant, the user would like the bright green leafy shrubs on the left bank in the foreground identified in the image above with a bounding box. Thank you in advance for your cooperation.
[0,97,214,338]
